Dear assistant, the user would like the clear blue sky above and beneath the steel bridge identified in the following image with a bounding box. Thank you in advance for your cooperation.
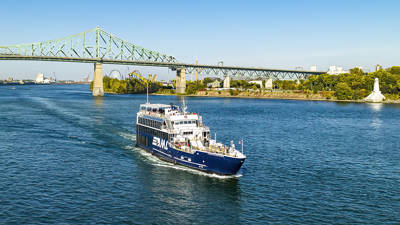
[0,0,400,79]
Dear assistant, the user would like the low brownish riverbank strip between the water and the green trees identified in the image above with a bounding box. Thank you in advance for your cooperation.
[152,90,400,104]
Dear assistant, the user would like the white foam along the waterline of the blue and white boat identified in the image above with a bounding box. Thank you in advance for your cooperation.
[119,132,243,179]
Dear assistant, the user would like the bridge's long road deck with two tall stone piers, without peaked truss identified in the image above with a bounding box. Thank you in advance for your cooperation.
[0,54,324,96]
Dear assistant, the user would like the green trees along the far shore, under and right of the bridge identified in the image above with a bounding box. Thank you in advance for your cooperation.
[95,66,400,100]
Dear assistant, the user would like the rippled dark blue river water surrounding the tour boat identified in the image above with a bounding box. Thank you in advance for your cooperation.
[0,85,400,224]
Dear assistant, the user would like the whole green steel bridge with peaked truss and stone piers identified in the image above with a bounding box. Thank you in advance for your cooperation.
[0,27,324,95]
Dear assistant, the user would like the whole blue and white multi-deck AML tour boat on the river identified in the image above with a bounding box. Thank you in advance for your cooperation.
[136,101,246,175]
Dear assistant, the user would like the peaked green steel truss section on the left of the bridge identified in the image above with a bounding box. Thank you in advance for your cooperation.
[0,27,176,63]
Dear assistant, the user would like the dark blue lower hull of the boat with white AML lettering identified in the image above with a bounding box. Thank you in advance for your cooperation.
[136,131,245,175]
